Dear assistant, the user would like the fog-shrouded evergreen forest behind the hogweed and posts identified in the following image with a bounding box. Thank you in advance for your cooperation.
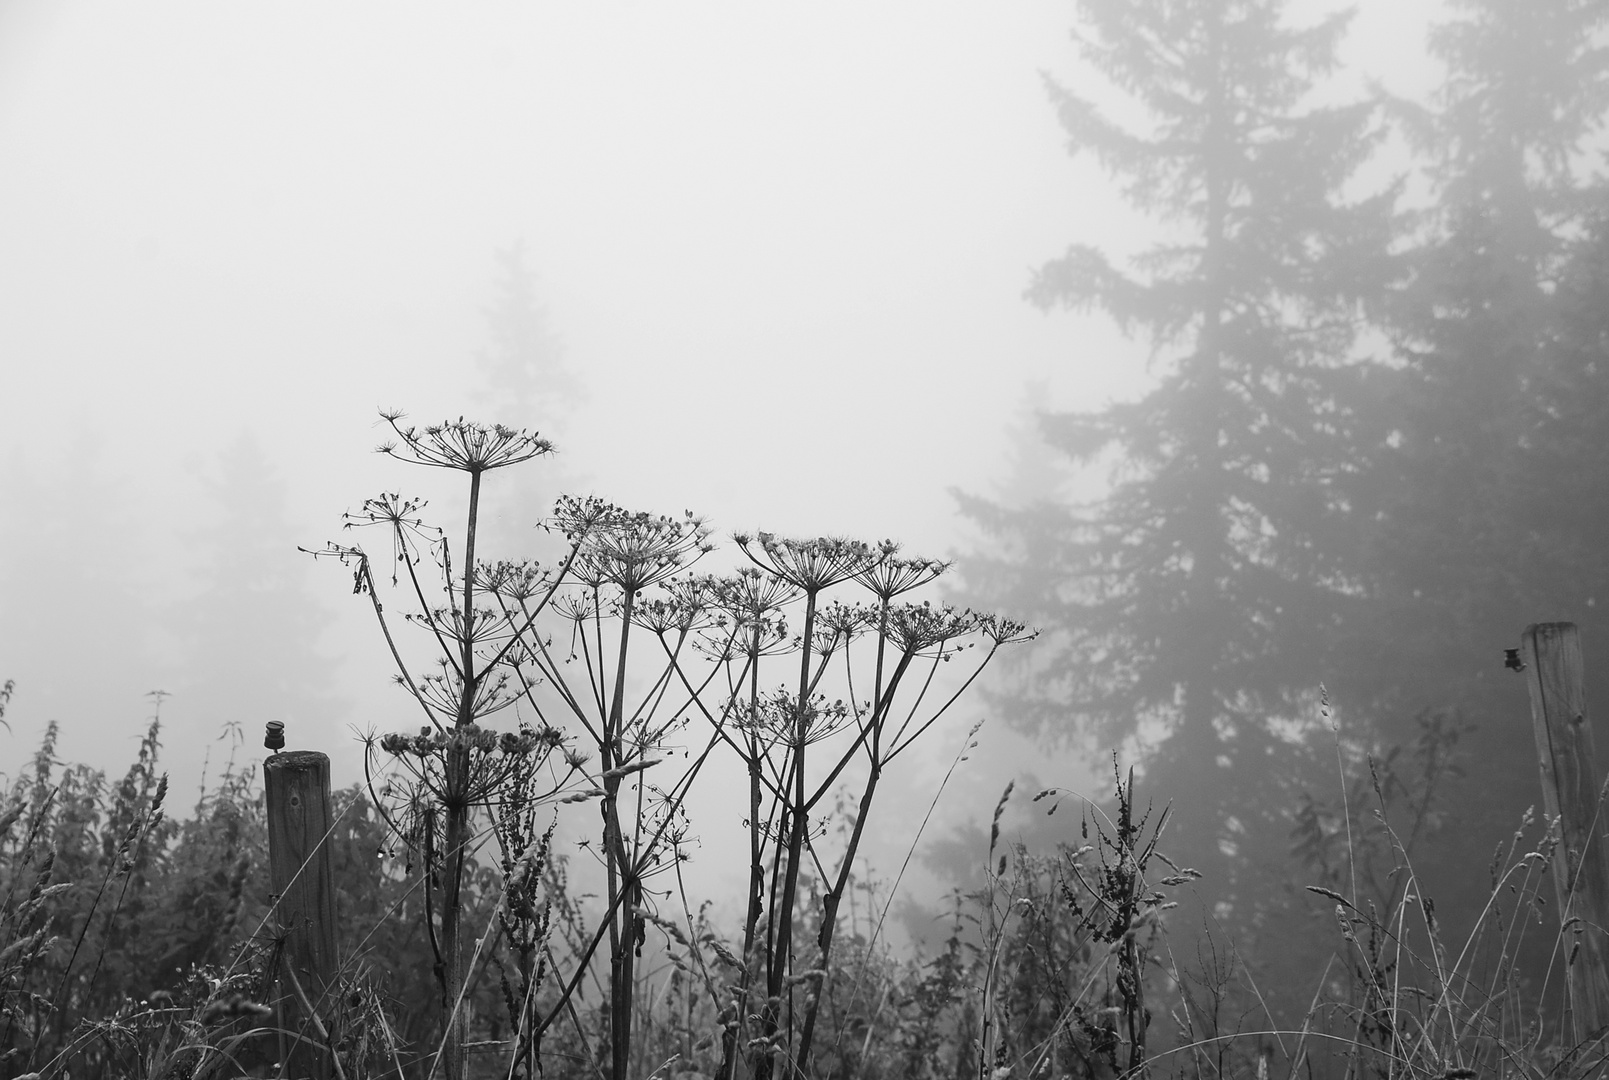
[0,0,1609,1062]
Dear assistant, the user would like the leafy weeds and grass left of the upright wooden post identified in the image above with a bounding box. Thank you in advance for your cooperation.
[0,695,265,1075]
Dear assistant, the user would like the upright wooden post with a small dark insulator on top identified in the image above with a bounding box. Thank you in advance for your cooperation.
[262,721,336,1080]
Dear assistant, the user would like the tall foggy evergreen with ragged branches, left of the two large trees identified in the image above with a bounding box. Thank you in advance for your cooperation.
[964,0,1393,927]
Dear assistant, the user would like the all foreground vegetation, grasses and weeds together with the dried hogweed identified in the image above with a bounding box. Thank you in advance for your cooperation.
[0,415,1606,1080]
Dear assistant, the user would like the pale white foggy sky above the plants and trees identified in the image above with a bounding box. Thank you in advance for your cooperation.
[0,0,1429,843]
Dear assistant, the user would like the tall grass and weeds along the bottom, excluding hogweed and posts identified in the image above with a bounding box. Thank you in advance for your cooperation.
[0,688,1609,1080]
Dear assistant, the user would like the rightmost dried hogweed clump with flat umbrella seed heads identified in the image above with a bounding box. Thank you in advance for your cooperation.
[678,533,1028,1078]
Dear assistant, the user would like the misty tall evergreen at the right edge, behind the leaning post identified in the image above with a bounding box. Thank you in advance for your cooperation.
[1339,0,1609,952]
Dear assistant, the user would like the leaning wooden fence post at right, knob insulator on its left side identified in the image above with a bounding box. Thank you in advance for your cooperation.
[1521,623,1609,1045]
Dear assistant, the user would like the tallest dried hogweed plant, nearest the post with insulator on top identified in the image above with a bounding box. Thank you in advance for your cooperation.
[302,412,592,1078]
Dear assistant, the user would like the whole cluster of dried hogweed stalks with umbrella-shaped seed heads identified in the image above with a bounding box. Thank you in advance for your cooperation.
[314,414,1028,1080]
